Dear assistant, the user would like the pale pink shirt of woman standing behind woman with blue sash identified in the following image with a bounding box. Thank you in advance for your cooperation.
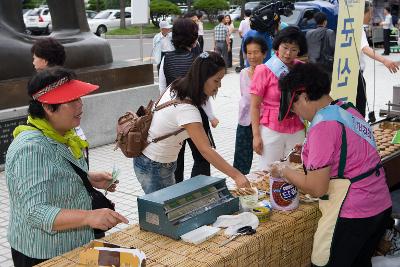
[239,68,251,126]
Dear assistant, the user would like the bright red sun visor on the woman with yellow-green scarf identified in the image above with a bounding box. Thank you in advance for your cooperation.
[32,80,99,104]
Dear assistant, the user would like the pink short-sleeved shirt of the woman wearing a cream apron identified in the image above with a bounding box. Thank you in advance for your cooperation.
[302,103,392,218]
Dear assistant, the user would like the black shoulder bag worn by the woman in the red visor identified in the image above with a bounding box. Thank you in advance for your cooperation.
[69,161,115,238]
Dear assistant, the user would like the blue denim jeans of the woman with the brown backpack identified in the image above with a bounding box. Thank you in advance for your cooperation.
[133,154,176,194]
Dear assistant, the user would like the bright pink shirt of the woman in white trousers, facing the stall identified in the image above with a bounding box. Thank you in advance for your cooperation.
[250,63,304,134]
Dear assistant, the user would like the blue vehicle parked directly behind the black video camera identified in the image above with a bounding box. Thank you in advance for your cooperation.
[281,1,338,32]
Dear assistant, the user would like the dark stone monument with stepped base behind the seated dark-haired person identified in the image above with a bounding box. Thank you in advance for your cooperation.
[0,0,158,168]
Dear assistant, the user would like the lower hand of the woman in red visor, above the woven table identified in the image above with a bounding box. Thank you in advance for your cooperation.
[86,208,129,231]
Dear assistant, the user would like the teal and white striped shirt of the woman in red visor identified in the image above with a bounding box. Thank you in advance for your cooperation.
[5,131,94,259]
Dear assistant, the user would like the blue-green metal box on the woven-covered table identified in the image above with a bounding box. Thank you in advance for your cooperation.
[137,175,239,239]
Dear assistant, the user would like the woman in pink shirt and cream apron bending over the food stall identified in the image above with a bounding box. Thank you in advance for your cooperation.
[271,64,392,267]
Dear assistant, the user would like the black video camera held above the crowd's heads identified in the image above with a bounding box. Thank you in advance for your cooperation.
[250,1,294,35]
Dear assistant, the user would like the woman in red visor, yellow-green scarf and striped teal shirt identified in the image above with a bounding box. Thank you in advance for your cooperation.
[5,67,127,267]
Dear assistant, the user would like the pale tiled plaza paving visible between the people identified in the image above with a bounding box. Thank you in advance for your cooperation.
[0,49,400,267]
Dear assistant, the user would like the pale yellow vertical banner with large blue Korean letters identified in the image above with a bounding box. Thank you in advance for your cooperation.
[331,0,365,103]
